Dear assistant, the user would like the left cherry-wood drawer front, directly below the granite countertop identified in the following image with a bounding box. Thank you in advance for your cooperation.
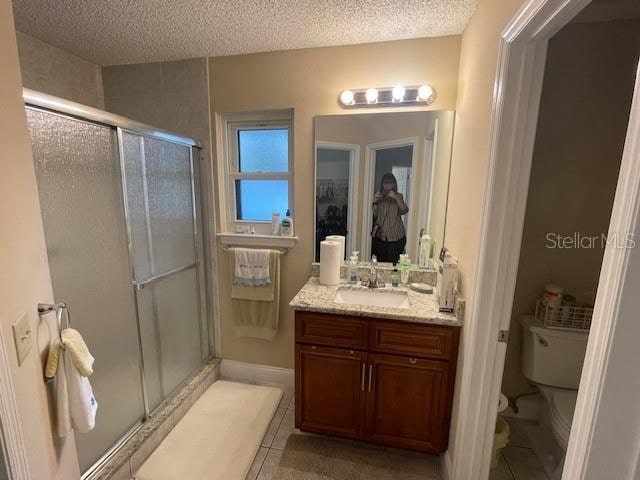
[296,312,368,350]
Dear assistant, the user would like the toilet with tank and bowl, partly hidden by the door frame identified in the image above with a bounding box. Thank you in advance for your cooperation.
[520,315,589,478]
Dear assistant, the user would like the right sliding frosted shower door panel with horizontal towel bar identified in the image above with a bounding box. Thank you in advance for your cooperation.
[122,132,202,410]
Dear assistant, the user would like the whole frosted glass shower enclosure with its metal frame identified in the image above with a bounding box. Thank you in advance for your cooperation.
[24,90,213,476]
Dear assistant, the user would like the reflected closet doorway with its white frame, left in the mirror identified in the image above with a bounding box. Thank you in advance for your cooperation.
[314,142,360,261]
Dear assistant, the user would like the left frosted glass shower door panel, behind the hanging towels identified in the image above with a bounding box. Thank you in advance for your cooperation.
[27,109,145,469]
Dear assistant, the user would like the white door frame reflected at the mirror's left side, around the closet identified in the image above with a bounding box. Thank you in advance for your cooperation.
[313,140,360,260]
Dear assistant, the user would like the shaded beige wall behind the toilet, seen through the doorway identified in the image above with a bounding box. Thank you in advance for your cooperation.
[502,20,640,395]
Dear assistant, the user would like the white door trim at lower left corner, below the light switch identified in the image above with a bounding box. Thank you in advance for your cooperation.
[0,331,31,480]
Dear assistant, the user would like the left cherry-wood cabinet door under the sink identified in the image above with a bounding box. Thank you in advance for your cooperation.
[295,344,367,438]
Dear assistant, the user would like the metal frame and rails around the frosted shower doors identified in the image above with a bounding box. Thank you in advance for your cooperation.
[23,88,217,479]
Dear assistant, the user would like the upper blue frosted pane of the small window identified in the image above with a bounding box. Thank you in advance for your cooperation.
[238,129,289,172]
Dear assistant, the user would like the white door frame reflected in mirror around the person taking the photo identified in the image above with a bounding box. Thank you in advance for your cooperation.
[360,137,420,262]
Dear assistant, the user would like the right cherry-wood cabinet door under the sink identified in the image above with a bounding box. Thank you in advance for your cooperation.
[365,354,452,453]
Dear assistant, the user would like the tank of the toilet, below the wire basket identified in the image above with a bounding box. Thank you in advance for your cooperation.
[520,315,589,389]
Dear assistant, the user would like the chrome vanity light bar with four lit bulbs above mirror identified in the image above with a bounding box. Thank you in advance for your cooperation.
[338,85,436,108]
